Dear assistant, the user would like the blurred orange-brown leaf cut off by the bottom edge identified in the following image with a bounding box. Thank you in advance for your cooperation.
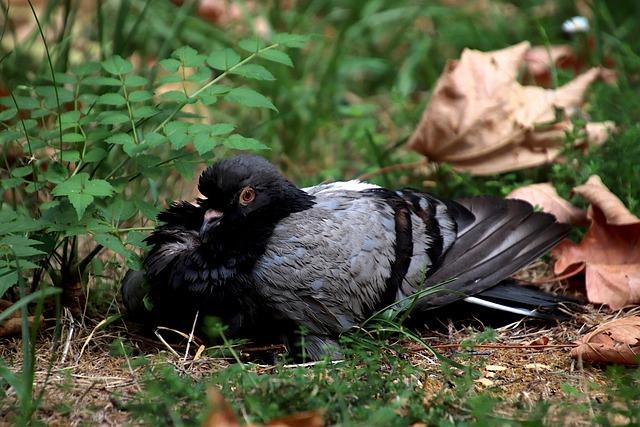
[202,387,324,427]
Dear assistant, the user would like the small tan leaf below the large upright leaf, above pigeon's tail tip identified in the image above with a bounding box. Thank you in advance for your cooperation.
[507,183,587,225]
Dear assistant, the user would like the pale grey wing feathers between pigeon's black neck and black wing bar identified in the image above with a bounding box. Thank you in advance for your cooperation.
[252,189,396,334]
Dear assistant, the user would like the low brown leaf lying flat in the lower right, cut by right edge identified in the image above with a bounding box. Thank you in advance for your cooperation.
[571,316,640,365]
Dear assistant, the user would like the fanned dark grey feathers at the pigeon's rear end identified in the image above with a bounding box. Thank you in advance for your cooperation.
[417,197,569,314]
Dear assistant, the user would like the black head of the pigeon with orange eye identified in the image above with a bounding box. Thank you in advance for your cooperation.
[198,155,313,243]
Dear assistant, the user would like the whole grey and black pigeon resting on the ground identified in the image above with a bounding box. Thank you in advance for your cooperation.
[122,154,570,360]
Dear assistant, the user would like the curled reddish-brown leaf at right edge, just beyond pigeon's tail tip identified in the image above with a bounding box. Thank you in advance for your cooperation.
[551,176,640,309]
